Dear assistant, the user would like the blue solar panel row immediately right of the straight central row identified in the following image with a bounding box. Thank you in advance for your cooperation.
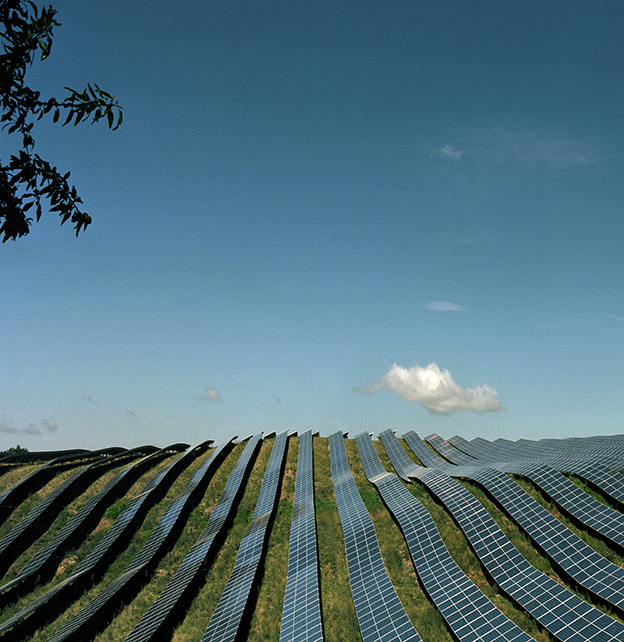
[329,432,420,642]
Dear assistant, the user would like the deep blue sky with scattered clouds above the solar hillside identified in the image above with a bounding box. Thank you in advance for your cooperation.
[0,0,624,450]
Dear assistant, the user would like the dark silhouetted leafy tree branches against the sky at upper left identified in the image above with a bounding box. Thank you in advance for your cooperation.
[0,0,123,243]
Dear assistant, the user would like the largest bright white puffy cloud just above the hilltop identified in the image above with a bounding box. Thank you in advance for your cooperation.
[359,363,502,415]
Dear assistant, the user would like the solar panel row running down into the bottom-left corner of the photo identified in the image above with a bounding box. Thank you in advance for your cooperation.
[0,449,193,635]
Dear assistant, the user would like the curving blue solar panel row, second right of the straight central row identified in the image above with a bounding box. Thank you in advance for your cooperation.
[355,431,533,642]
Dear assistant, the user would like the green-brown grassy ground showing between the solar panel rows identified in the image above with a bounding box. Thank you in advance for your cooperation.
[0,437,624,642]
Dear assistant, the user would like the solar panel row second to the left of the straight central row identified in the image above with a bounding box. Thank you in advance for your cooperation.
[126,434,262,642]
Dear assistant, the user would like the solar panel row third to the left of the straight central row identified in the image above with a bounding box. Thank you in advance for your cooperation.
[48,440,231,642]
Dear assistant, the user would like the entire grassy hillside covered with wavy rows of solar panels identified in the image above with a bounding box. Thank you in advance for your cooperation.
[0,430,624,642]
